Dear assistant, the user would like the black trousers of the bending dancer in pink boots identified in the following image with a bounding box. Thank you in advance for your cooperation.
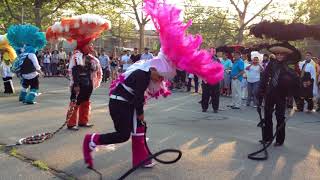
[99,99,134,144]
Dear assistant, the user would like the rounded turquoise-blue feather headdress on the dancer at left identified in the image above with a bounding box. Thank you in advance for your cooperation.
[7,25,47,54]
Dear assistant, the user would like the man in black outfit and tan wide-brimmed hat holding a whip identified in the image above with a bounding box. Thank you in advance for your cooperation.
[258,44,299,146]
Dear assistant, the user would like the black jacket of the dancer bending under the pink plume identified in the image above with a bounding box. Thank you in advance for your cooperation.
[112,69,151,115]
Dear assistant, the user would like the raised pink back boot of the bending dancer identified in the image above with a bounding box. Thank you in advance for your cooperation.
[82,134,100,168]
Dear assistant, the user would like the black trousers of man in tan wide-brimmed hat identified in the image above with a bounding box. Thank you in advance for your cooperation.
[262,93,286,144]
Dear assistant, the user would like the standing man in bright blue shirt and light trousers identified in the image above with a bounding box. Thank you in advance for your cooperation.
[230,52,244,109]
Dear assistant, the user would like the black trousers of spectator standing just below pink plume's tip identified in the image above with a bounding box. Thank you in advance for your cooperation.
[201,82,220,110]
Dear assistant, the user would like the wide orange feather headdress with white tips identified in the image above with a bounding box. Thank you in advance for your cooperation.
[46,14,111,50]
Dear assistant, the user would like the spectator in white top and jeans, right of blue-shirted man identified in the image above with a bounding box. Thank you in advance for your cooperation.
[246,57,263,107]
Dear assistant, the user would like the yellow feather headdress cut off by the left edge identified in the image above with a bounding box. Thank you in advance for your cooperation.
[0,35,17,63]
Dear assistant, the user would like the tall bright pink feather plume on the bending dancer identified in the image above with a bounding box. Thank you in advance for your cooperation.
[144,0,223,84]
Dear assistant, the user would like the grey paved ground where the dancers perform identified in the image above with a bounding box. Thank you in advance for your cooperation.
[0,78,320,180]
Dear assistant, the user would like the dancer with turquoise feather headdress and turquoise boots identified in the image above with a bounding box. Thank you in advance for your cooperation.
[7,25,47,104]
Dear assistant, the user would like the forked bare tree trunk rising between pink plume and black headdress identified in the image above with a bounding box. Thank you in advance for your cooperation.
[229,0,273,44]
